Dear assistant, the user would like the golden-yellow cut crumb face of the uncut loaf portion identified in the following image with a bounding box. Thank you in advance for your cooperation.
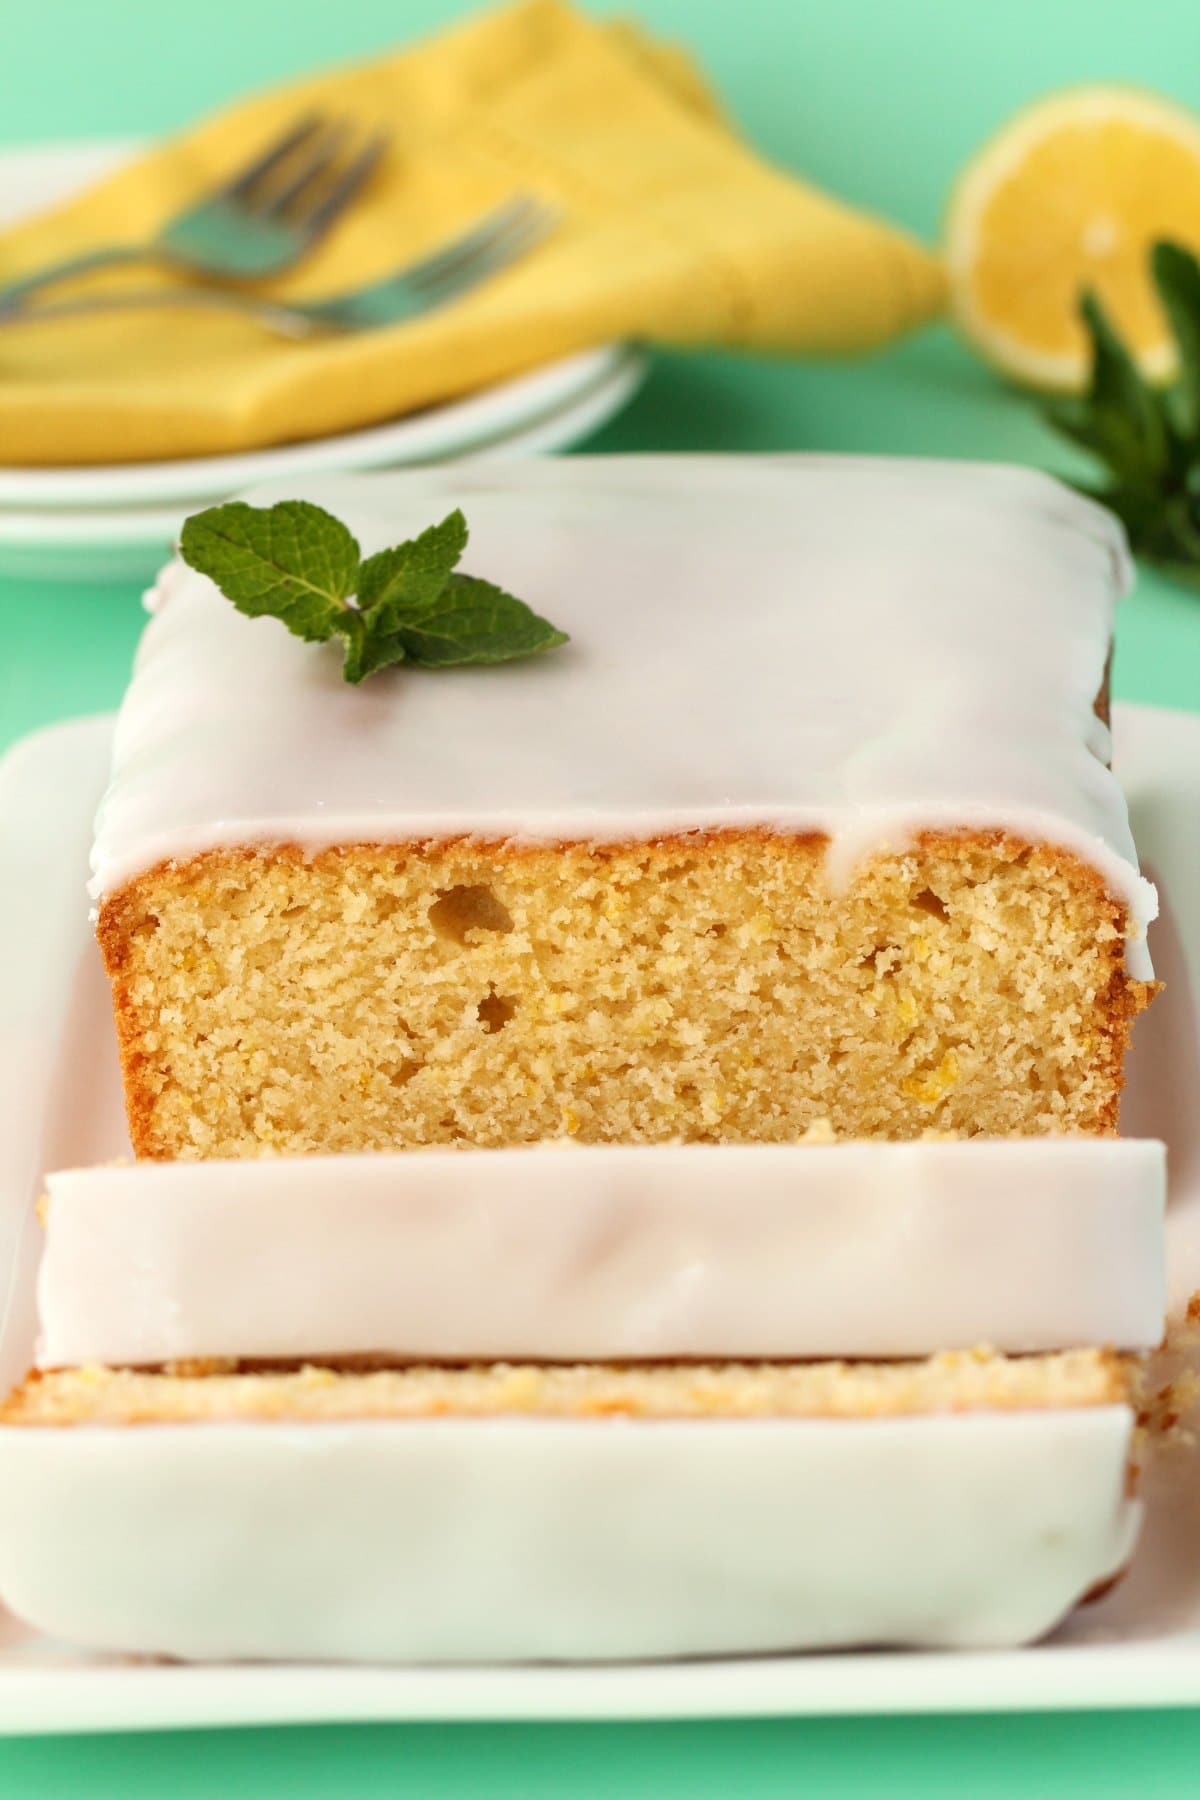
[99,832,1150,1157]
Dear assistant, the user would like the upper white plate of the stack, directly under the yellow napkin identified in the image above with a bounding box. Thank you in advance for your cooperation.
[0,140,646,515]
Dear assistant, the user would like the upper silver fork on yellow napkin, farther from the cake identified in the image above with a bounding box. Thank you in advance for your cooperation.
[0,113,387,319]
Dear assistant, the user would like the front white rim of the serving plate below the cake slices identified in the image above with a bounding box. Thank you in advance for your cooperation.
[0,1633,1200,1737]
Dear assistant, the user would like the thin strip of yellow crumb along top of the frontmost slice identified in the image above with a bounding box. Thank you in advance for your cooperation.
[0,1350,1128,1426]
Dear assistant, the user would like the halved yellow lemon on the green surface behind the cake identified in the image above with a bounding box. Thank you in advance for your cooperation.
[946,86,1200,391]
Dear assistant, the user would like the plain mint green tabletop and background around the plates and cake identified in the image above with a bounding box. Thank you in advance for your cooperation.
[0,0,1200,1800]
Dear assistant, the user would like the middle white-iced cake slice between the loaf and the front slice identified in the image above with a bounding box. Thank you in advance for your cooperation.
[36,1130,1166,1370]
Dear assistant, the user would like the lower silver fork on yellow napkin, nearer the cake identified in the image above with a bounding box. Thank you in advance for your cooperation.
[0,194,561,338]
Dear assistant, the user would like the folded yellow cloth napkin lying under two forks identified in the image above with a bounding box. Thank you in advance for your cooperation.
[0,0,943,464]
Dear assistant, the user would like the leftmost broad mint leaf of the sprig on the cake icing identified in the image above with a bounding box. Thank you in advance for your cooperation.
[180,500,360,643]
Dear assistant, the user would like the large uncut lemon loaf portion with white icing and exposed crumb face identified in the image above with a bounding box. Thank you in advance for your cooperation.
[94,455,1155,1159]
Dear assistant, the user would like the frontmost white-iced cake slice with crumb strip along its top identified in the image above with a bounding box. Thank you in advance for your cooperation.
[0,1350,1139,1661]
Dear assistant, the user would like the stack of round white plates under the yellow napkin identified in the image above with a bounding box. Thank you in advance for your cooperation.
[0,142,646,581]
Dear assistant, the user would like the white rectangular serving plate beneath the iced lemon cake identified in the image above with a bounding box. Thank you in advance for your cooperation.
[0,707,1200,1733]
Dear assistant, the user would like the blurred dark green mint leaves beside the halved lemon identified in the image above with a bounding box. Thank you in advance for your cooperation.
[1045,243,1200,585]
